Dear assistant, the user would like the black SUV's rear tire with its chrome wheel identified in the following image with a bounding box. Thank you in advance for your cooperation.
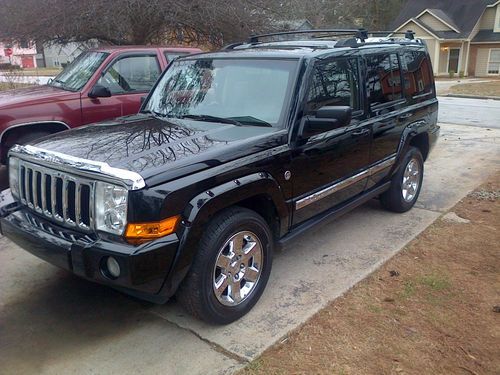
[380,147,424,212]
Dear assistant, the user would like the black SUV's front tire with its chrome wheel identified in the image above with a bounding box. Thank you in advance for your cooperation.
[177,207,273,324]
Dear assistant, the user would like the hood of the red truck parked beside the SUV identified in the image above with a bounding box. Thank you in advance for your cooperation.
[0,85,80,109]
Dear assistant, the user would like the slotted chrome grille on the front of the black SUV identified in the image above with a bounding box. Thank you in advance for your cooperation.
[19,160,94,231]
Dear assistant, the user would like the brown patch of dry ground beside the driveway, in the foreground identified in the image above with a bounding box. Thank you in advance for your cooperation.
[242,174,500,374]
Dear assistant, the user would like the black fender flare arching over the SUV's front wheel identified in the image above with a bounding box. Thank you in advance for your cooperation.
[159,172,289,298]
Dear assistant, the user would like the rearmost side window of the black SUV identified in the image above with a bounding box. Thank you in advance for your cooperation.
[401,51,432,102]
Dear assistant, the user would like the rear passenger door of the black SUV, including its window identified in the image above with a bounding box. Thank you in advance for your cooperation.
[365,50,411,188]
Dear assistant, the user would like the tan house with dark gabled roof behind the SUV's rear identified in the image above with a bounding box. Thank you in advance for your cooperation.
[391,0,500,77]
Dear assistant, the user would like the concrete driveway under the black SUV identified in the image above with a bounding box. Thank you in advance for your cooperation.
[0,124,500,374]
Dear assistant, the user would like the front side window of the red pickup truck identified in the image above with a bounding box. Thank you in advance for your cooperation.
[97,55,160,94]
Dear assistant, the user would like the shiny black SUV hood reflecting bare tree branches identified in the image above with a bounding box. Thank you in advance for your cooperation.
[31,114,282,185]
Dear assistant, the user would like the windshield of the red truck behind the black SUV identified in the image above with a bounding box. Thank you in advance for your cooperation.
[50,52,108,91]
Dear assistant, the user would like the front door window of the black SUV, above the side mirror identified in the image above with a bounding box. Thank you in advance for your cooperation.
[305,59,361,114]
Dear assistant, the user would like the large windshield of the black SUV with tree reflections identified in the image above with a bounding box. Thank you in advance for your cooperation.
[143,59,298,126]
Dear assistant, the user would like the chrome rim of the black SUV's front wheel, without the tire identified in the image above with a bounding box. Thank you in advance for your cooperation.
[213,231,263,306]
